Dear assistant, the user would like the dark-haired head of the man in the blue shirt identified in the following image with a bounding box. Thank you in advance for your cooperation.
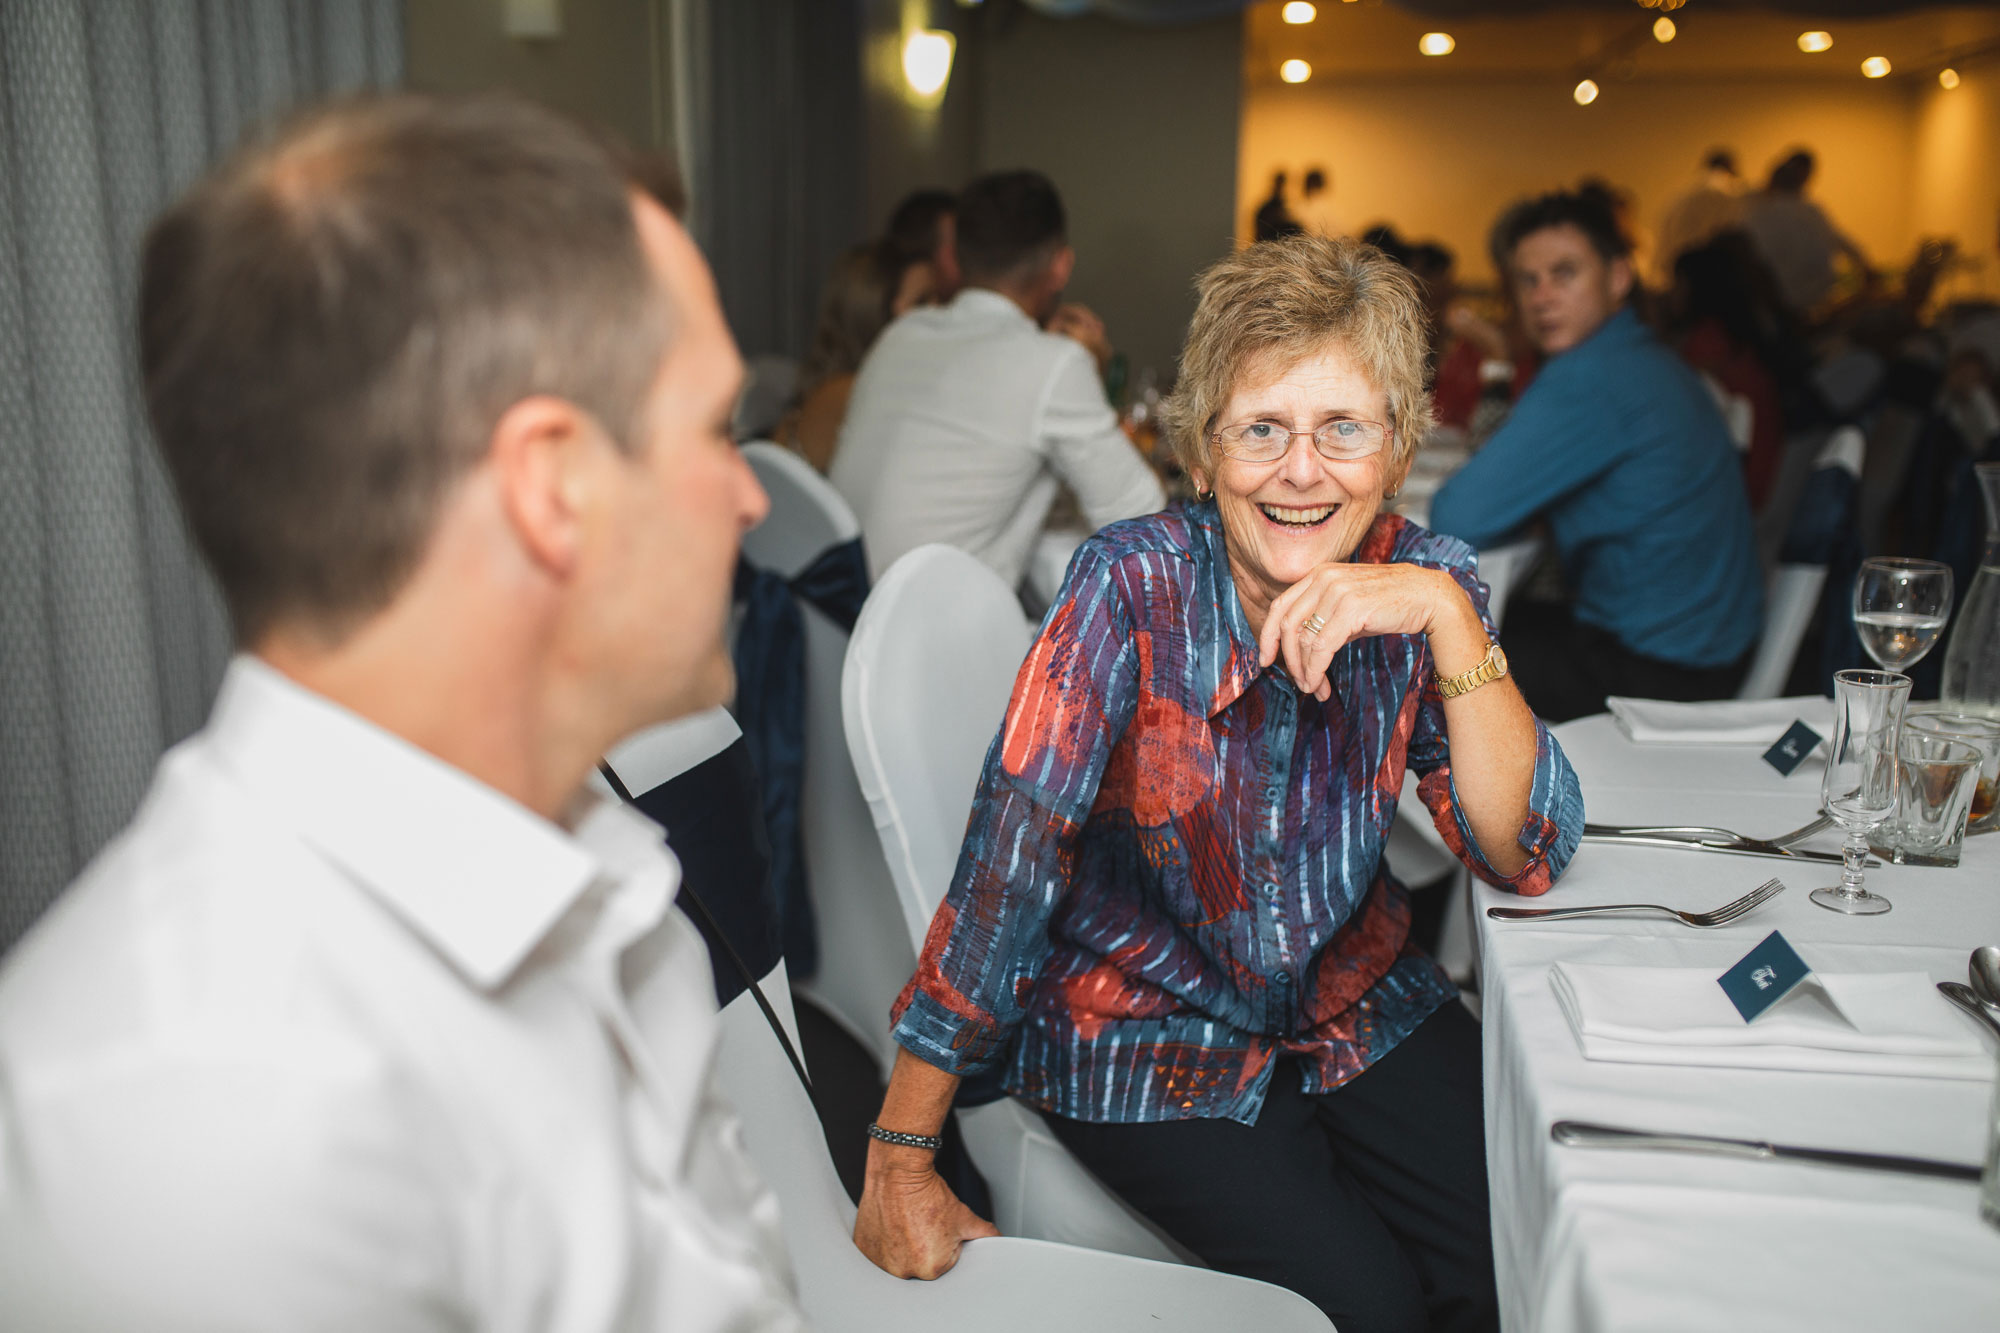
[1492,190,1632,356]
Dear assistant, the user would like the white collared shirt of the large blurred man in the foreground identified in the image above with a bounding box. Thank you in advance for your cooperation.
[0,658,802,1333]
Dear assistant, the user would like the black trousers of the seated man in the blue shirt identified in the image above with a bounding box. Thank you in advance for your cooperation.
[1500,602,1756,723]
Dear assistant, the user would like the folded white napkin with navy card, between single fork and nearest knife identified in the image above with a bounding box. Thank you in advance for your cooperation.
[1548,963,1994,1083]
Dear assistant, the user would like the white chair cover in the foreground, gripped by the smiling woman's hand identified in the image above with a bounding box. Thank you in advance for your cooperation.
[716,963,1332,1333]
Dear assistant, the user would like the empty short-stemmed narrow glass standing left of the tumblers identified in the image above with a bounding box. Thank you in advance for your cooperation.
[1812,671,1910,917]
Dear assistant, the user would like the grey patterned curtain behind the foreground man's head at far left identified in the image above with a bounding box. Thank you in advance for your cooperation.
[0,0,402,951]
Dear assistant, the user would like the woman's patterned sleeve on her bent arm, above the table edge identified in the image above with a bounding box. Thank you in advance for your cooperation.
[1410,548,1584,897]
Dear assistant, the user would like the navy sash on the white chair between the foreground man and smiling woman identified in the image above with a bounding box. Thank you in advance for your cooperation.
[736,536,868,981]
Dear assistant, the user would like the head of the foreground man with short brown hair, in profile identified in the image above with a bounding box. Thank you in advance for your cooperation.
[140,96,764,748]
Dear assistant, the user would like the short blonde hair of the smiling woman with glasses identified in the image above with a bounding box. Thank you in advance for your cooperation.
[1164,234,1430,476]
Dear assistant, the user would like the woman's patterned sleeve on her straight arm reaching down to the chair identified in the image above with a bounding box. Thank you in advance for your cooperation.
[890,546,1138,1077]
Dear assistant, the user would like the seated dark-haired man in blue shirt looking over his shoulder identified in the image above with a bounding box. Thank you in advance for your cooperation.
[1430,194,1764,721]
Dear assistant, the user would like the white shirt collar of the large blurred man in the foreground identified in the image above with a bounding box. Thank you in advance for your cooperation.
[208,656,678,989]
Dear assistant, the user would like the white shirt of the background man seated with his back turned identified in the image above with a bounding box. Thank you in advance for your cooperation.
[830,286,1166,586]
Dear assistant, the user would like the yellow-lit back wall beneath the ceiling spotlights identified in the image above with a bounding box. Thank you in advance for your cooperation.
[1236,78,1912,282]
